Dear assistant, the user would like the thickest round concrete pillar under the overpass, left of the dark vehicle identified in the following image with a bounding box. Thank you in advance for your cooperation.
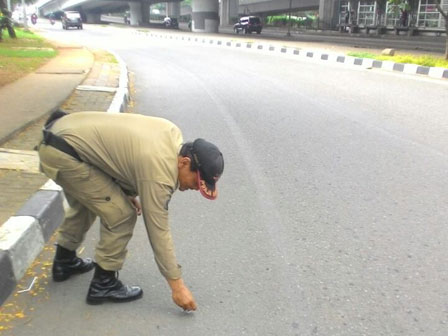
[191,0,219,33]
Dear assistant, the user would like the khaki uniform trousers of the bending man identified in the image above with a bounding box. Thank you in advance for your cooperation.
[39,144,137,271]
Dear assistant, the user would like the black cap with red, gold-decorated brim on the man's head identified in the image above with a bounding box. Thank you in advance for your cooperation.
[191,139,224,200]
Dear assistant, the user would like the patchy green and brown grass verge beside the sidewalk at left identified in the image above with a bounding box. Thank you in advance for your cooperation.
[0,28,57,87]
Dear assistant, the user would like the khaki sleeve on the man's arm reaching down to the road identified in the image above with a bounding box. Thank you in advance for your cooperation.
[138,180,181,280]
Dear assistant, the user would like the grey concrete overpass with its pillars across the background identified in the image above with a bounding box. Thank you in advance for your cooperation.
[39,0,337,33]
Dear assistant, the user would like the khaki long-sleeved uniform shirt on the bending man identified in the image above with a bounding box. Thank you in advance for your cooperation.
[51,112,182,279]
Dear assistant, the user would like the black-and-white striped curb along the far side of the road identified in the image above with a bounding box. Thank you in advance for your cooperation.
[135,31,448,79]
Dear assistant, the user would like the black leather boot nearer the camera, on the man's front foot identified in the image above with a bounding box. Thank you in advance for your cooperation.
[87,264,143,305]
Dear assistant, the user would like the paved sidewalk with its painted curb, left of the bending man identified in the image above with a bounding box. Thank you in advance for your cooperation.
[0,45,129,305]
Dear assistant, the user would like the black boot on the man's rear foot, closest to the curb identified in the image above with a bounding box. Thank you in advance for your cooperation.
[52,245,94,282]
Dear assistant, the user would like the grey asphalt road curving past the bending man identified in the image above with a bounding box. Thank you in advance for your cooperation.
[4,21,448,336]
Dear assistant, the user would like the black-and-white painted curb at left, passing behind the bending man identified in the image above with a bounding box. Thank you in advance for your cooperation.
[0,50,129,306]
